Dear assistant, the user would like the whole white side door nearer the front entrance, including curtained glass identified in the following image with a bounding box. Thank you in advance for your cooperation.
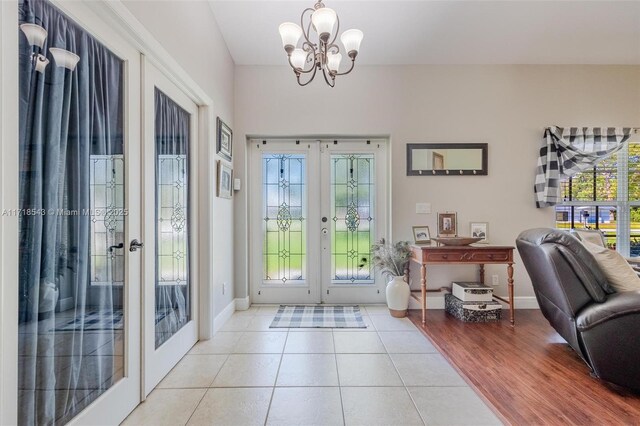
[142,60,198,396]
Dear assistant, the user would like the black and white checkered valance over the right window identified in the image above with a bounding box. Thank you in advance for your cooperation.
[534,126,632,208]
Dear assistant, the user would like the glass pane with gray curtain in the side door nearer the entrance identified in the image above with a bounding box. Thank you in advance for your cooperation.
[155,89,191,348]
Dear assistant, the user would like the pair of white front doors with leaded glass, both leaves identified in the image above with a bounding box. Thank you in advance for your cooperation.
[250,140,388,304]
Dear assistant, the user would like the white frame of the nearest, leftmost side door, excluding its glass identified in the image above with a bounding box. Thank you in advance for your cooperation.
[0,0,141,425]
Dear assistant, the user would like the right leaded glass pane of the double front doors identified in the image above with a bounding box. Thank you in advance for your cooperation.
[329,154,376,284]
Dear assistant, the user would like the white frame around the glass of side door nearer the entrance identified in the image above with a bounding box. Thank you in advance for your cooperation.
[142,55,200,399]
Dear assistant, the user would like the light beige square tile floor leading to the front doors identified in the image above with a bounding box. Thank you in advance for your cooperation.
[124,306,500,426]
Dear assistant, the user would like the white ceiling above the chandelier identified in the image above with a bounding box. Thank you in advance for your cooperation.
[209,0,640,65]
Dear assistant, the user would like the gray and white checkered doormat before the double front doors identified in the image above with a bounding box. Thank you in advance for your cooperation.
[269,305,367,328]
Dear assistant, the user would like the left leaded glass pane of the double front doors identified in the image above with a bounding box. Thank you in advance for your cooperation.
[262,154,307,285]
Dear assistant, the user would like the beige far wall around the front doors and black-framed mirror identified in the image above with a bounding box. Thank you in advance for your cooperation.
[234,65,640,301]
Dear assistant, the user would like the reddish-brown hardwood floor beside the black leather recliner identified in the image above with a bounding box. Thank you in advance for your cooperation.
[409,310,640,425]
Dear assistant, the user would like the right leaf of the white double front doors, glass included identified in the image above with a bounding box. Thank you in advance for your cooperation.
[320,140,388,303]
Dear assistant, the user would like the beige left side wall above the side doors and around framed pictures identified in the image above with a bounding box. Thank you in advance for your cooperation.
[124,0,234,316]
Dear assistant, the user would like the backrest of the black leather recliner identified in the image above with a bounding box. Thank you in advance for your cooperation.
[516,228,614,356]
